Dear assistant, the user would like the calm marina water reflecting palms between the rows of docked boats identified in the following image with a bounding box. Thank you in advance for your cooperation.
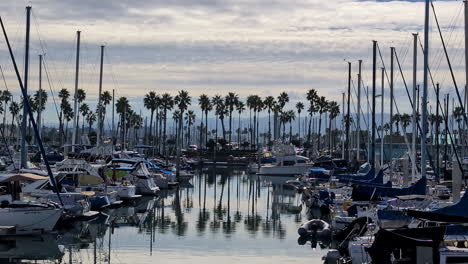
[0,168,326,264]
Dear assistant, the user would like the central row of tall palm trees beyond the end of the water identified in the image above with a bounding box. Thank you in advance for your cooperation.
[139,89,340,150]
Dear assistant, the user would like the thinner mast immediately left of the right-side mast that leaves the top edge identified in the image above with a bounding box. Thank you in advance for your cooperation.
[411,33,418,180]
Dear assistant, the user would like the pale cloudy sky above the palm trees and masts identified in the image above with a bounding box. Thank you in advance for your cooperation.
[0,0,465,125]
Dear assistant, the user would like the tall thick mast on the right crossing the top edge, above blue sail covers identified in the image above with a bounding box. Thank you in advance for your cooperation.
[421,0,430,177]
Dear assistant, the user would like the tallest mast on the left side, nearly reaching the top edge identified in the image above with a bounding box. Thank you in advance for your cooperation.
[20,6,31,169]
